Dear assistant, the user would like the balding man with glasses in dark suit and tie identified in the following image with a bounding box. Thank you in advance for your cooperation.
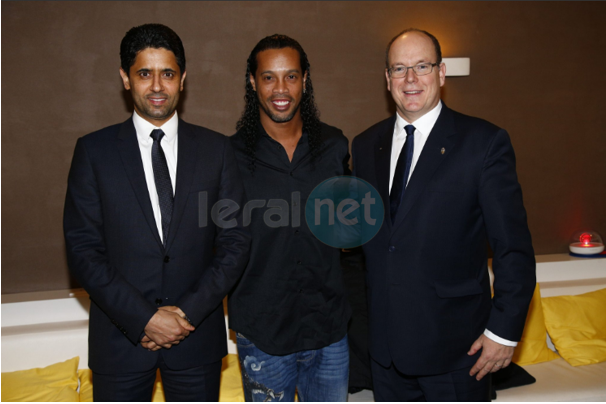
[352,29,535,401]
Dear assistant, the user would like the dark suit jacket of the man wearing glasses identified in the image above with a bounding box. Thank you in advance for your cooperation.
[352,105,535,375]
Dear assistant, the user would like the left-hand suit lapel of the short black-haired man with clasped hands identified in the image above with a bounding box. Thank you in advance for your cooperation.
[118,118,162,247]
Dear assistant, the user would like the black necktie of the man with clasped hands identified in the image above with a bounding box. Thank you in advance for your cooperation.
[150,129,173,247]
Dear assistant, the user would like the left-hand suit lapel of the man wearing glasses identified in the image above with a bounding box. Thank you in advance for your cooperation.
[375,115,396,225]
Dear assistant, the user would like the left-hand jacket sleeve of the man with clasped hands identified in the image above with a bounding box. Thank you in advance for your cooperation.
[63,139,157,344]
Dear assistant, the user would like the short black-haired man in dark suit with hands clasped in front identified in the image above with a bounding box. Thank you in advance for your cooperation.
[64,24,250,401]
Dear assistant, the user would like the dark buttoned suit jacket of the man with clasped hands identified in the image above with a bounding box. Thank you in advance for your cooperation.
[64,119,250,374]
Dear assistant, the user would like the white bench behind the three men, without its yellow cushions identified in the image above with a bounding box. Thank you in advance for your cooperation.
[2,254,606,401]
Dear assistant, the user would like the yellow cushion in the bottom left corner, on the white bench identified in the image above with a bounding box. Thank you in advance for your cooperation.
[2,357,80,402]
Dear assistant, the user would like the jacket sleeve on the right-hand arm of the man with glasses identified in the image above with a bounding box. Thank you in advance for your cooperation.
[479,129,536,341]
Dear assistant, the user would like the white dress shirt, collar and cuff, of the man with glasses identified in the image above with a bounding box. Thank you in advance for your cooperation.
[389,101,518,346]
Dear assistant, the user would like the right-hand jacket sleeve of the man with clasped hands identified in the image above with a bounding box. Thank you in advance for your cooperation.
[177,137,251,326]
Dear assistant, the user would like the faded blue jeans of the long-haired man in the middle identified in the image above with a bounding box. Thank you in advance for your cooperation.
[236,333,349,401]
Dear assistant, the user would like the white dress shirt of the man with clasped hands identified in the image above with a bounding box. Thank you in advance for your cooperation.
[133,111,179,241]
